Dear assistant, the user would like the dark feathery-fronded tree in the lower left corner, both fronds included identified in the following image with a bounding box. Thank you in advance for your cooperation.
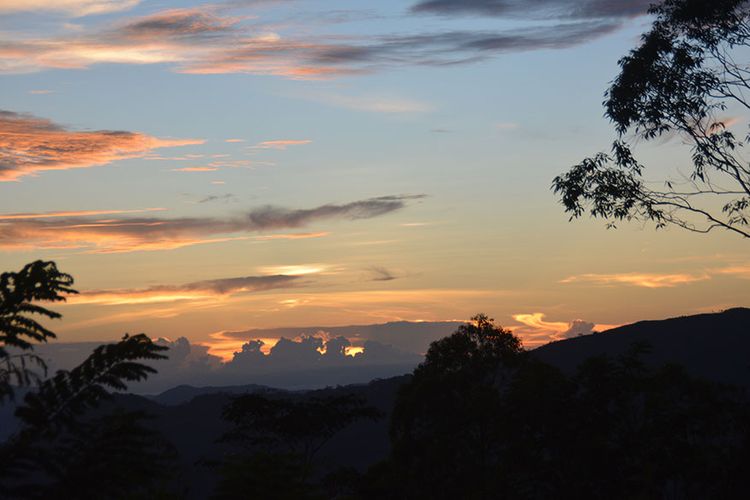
[0,261,172,499]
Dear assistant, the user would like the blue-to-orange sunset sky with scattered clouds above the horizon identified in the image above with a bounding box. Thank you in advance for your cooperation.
[0,0,750,359]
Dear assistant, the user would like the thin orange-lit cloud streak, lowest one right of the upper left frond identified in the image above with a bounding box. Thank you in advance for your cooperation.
[68,275,299,306]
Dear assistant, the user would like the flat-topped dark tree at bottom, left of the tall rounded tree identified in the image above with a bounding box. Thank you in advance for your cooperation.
[217,394,381,499]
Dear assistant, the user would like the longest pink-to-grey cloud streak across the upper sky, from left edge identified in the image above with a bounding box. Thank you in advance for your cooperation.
[0,6,621,77]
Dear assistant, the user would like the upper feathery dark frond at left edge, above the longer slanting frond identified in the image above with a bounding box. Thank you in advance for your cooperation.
[0,260,77,404]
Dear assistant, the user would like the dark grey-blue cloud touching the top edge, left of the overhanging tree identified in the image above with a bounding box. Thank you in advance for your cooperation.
[411,0,654,19]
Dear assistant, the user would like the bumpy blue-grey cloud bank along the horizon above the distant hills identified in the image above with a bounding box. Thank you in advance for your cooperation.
[25,321,458,394]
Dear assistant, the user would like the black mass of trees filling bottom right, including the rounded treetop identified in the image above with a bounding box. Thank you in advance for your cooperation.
[368,316,750,499]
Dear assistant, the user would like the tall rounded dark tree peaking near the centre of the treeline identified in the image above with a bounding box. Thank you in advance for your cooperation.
[382,314,526,498]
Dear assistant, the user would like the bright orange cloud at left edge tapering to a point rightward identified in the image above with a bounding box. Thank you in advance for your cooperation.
[0,109,203,182]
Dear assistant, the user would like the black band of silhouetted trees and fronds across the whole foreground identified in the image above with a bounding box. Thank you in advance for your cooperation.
[0,261,750,499]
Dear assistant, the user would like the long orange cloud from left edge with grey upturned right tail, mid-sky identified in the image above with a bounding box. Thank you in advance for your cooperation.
[0,195,423,253]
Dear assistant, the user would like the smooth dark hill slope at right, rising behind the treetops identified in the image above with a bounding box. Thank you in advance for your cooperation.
[533,308,750,387]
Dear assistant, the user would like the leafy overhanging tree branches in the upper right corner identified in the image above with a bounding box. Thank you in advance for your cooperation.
[552,0,750,237]
